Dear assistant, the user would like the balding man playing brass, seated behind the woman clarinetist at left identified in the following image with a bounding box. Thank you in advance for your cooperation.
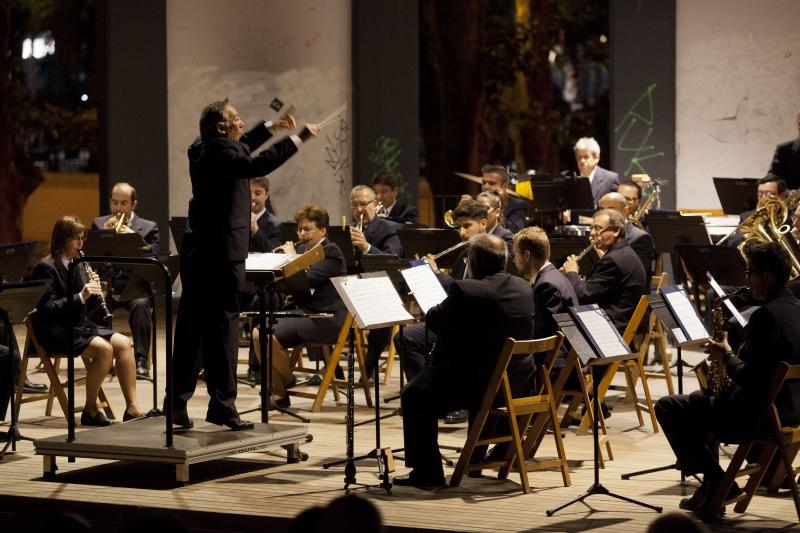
[92,182,159,378]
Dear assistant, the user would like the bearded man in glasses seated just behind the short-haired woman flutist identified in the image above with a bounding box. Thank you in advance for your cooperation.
[350,185,403,258]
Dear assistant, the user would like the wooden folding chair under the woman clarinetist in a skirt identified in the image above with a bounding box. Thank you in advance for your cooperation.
[14,311,114,420]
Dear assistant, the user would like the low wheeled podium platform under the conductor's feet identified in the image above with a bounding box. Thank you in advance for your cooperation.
[33,416,313,483]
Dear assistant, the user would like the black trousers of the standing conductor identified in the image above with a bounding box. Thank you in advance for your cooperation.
[173,241,244,420]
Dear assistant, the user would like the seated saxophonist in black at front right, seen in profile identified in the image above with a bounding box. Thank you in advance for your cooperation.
[655,242,800,514]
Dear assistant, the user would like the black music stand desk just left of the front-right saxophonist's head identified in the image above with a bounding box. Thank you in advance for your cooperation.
[675,243,746,286]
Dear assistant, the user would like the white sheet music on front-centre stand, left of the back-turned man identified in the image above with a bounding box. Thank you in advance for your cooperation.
[331,276,414,329]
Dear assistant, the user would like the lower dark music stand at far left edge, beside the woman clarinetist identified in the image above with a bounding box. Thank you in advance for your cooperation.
[0,280,50,459]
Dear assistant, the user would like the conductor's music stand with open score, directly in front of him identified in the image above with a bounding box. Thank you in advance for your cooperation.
[245,246,325,424]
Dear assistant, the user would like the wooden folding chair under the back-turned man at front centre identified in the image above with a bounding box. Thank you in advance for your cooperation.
[450,332,570,494]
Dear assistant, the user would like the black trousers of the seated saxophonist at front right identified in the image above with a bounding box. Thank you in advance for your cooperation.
[655,391,753,479]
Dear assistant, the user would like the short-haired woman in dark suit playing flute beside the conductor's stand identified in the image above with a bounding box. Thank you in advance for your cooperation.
[253,205,347,407]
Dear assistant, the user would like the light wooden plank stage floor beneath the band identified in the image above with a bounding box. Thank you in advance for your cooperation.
[0,324,799,532]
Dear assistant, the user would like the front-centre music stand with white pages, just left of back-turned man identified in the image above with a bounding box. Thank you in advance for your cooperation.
[323,272,414,494]
